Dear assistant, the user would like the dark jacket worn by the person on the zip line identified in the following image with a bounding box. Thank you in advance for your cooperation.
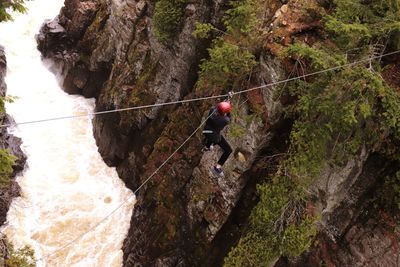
[203,107,231,144]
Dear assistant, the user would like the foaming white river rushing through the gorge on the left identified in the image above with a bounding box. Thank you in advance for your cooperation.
[0,0,134,267]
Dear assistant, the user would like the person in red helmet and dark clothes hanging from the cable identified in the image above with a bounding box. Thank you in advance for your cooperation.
[203,97,232,176]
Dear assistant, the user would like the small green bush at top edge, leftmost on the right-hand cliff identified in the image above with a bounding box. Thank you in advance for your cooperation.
[153,0,188,43]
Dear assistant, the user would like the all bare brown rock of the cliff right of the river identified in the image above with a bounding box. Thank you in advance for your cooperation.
[38,0,398,266]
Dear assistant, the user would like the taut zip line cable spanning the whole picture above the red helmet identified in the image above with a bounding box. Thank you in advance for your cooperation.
[0,50,400,128]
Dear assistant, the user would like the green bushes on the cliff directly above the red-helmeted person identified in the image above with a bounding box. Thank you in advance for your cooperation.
[193,0,260,90]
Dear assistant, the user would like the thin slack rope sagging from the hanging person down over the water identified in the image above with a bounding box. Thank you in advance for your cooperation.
[38,110,219,261]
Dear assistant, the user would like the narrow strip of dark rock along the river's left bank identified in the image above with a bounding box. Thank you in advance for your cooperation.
[0,46,26,225]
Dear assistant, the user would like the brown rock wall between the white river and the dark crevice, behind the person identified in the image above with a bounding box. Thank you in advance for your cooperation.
[38,1,280,266]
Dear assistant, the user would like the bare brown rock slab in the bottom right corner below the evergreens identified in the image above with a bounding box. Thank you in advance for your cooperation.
[275,154,400,267]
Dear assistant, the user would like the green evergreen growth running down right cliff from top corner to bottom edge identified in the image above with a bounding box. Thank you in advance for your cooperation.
[225,0,400,266]
